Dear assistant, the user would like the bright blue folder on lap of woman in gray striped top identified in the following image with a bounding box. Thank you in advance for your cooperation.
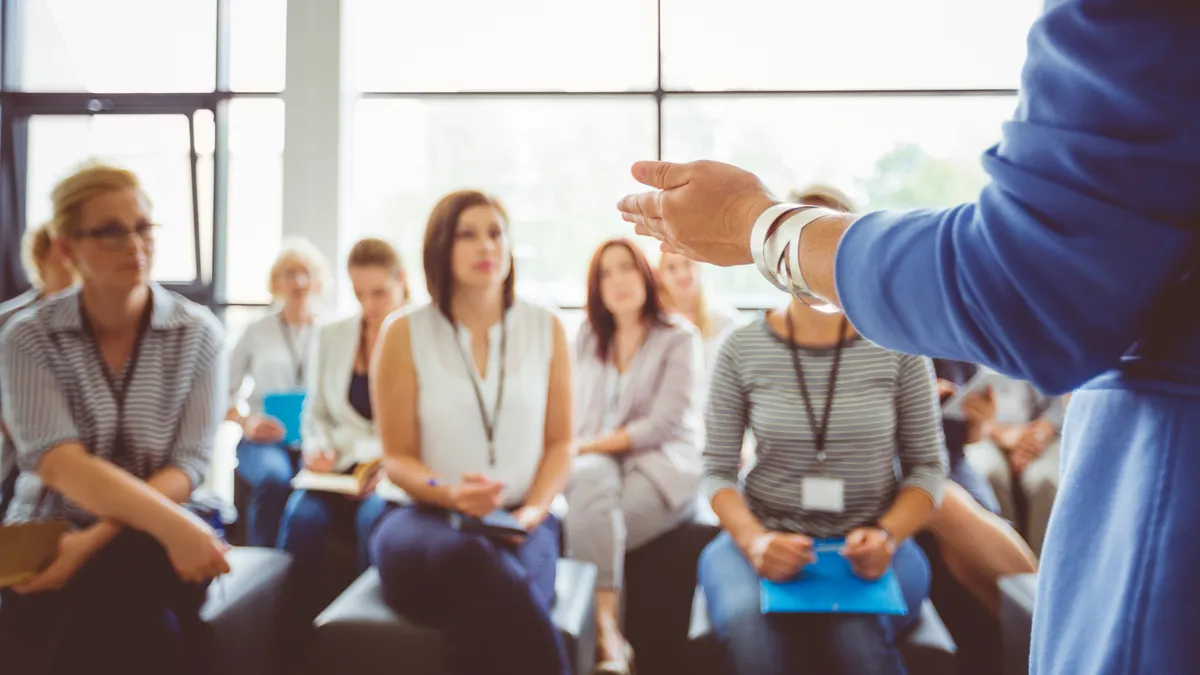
[760,539,908,615]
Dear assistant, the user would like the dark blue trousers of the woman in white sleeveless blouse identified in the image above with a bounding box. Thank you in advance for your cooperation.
[371,507,570,675]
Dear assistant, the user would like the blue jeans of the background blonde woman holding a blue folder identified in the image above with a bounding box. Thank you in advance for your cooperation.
[236,438,299,546]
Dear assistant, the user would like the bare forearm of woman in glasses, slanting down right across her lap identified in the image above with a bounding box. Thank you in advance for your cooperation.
[38,446,187,540]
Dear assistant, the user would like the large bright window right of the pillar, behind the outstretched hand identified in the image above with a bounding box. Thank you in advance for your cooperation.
[348,0,1040,306]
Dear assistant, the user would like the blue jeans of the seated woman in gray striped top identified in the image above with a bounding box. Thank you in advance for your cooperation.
[698,532,929,675]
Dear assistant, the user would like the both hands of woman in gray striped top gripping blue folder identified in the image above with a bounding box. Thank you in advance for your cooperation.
[744,527,895,581]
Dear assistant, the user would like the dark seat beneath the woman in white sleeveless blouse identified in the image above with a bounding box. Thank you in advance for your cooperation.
[307,560,596,675]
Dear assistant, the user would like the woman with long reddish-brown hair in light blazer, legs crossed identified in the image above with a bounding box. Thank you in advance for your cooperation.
[566,239,703,674]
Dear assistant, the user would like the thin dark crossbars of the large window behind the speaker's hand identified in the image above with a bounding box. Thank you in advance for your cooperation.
[358,0,1019,311]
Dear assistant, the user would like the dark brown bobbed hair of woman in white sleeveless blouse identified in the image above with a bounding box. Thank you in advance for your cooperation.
[421,190,516,321]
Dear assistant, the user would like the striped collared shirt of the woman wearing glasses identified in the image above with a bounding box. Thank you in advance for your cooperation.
[0,285,226,526]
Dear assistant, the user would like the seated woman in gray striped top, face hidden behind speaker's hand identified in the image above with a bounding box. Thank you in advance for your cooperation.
[700,294,946,675]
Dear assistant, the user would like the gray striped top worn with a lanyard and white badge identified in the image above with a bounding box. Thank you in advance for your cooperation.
[703,318,946,537]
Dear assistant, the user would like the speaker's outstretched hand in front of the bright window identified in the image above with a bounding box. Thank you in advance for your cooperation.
[617,161,779,267]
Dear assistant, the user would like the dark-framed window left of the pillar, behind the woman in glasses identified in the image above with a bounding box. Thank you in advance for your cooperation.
[0,0,287,304]
